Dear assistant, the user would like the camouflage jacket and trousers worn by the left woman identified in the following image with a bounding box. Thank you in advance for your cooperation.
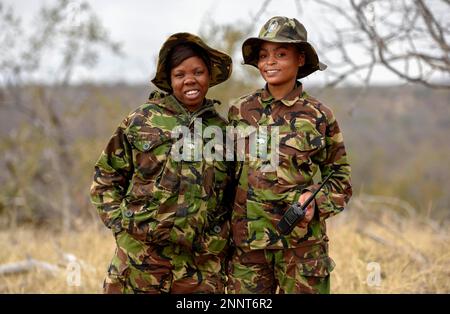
[91,93,232,293]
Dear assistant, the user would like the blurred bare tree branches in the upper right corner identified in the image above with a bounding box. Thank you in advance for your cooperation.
[304,0,450,88]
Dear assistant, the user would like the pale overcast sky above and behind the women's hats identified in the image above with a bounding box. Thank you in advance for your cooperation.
[2,0,442,84]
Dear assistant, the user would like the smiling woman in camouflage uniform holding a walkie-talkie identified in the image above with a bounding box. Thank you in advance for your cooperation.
[228,16,352,293]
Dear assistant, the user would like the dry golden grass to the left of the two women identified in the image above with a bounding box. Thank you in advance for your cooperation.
[0,222,114,293]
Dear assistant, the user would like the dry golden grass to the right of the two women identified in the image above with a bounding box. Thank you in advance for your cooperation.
[328,198,450,293]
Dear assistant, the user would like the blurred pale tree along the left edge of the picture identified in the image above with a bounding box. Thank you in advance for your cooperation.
[0,0,121,230]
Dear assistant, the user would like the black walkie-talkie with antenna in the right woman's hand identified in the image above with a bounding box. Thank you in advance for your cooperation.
[277,170,334,235]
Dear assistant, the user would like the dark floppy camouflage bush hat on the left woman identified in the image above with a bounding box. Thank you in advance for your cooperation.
[152,33,232,93]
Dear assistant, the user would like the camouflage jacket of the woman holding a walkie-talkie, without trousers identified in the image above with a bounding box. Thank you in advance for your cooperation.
[228,82,352,249]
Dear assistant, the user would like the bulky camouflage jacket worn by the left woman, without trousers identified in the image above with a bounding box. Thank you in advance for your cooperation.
[91,95,233,254]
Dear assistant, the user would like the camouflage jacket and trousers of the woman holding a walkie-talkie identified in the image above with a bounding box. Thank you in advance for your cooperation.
[228,82,352,293]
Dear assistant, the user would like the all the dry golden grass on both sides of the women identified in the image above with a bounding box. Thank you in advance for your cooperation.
[0,200,450,293]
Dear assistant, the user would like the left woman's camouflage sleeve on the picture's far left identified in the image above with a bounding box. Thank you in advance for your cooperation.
[90,119,133,232]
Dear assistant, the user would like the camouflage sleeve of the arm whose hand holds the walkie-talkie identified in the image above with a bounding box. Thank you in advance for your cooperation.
[306,110,352,220]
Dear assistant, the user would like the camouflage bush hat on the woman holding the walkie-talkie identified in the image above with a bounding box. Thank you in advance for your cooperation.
[242,16,327,79]
